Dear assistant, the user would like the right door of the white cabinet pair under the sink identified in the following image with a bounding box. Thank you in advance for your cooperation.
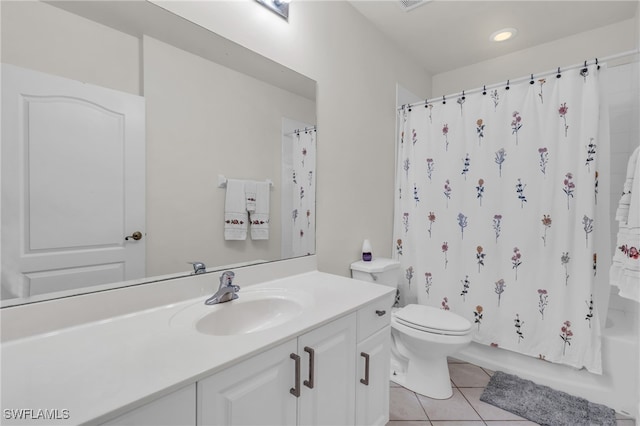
[298,313,356,426]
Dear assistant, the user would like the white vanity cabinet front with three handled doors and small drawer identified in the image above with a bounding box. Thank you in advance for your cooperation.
[197,298,390,426]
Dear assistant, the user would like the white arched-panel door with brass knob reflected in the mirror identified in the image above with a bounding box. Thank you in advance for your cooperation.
[0,64,145,297]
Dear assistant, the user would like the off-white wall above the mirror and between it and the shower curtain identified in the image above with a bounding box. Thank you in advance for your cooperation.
[150,0,431,275]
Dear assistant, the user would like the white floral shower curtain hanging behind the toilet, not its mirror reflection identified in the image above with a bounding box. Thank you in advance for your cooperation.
[394,65,610,373]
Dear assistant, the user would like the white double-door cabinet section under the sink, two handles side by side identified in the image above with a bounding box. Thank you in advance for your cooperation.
[197,314,356,426]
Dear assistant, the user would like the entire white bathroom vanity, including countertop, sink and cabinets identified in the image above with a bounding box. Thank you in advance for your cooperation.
[2,260,395,425]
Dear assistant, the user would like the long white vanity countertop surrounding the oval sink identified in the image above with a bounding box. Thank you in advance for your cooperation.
[1,271,394,424]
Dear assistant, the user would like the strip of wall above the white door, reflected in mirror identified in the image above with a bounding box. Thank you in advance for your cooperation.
[0,1,141,95]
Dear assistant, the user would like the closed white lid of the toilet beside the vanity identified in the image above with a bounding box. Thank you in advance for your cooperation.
[394,305,471,335]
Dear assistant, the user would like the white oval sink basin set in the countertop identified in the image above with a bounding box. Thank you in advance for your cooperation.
[170,289,308,336]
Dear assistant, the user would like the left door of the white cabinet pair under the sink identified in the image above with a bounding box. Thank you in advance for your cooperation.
[197,339,297,426]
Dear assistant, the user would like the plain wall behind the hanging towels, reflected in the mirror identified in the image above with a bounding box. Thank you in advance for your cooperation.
[143,37,315,276]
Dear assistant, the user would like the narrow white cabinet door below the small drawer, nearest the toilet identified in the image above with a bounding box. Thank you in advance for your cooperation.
[356,326,391,426]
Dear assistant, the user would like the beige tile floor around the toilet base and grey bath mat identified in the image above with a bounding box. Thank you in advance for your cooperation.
[387,359,635,426]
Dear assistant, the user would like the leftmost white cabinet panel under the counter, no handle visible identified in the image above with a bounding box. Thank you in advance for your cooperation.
[102,384,196,426]
